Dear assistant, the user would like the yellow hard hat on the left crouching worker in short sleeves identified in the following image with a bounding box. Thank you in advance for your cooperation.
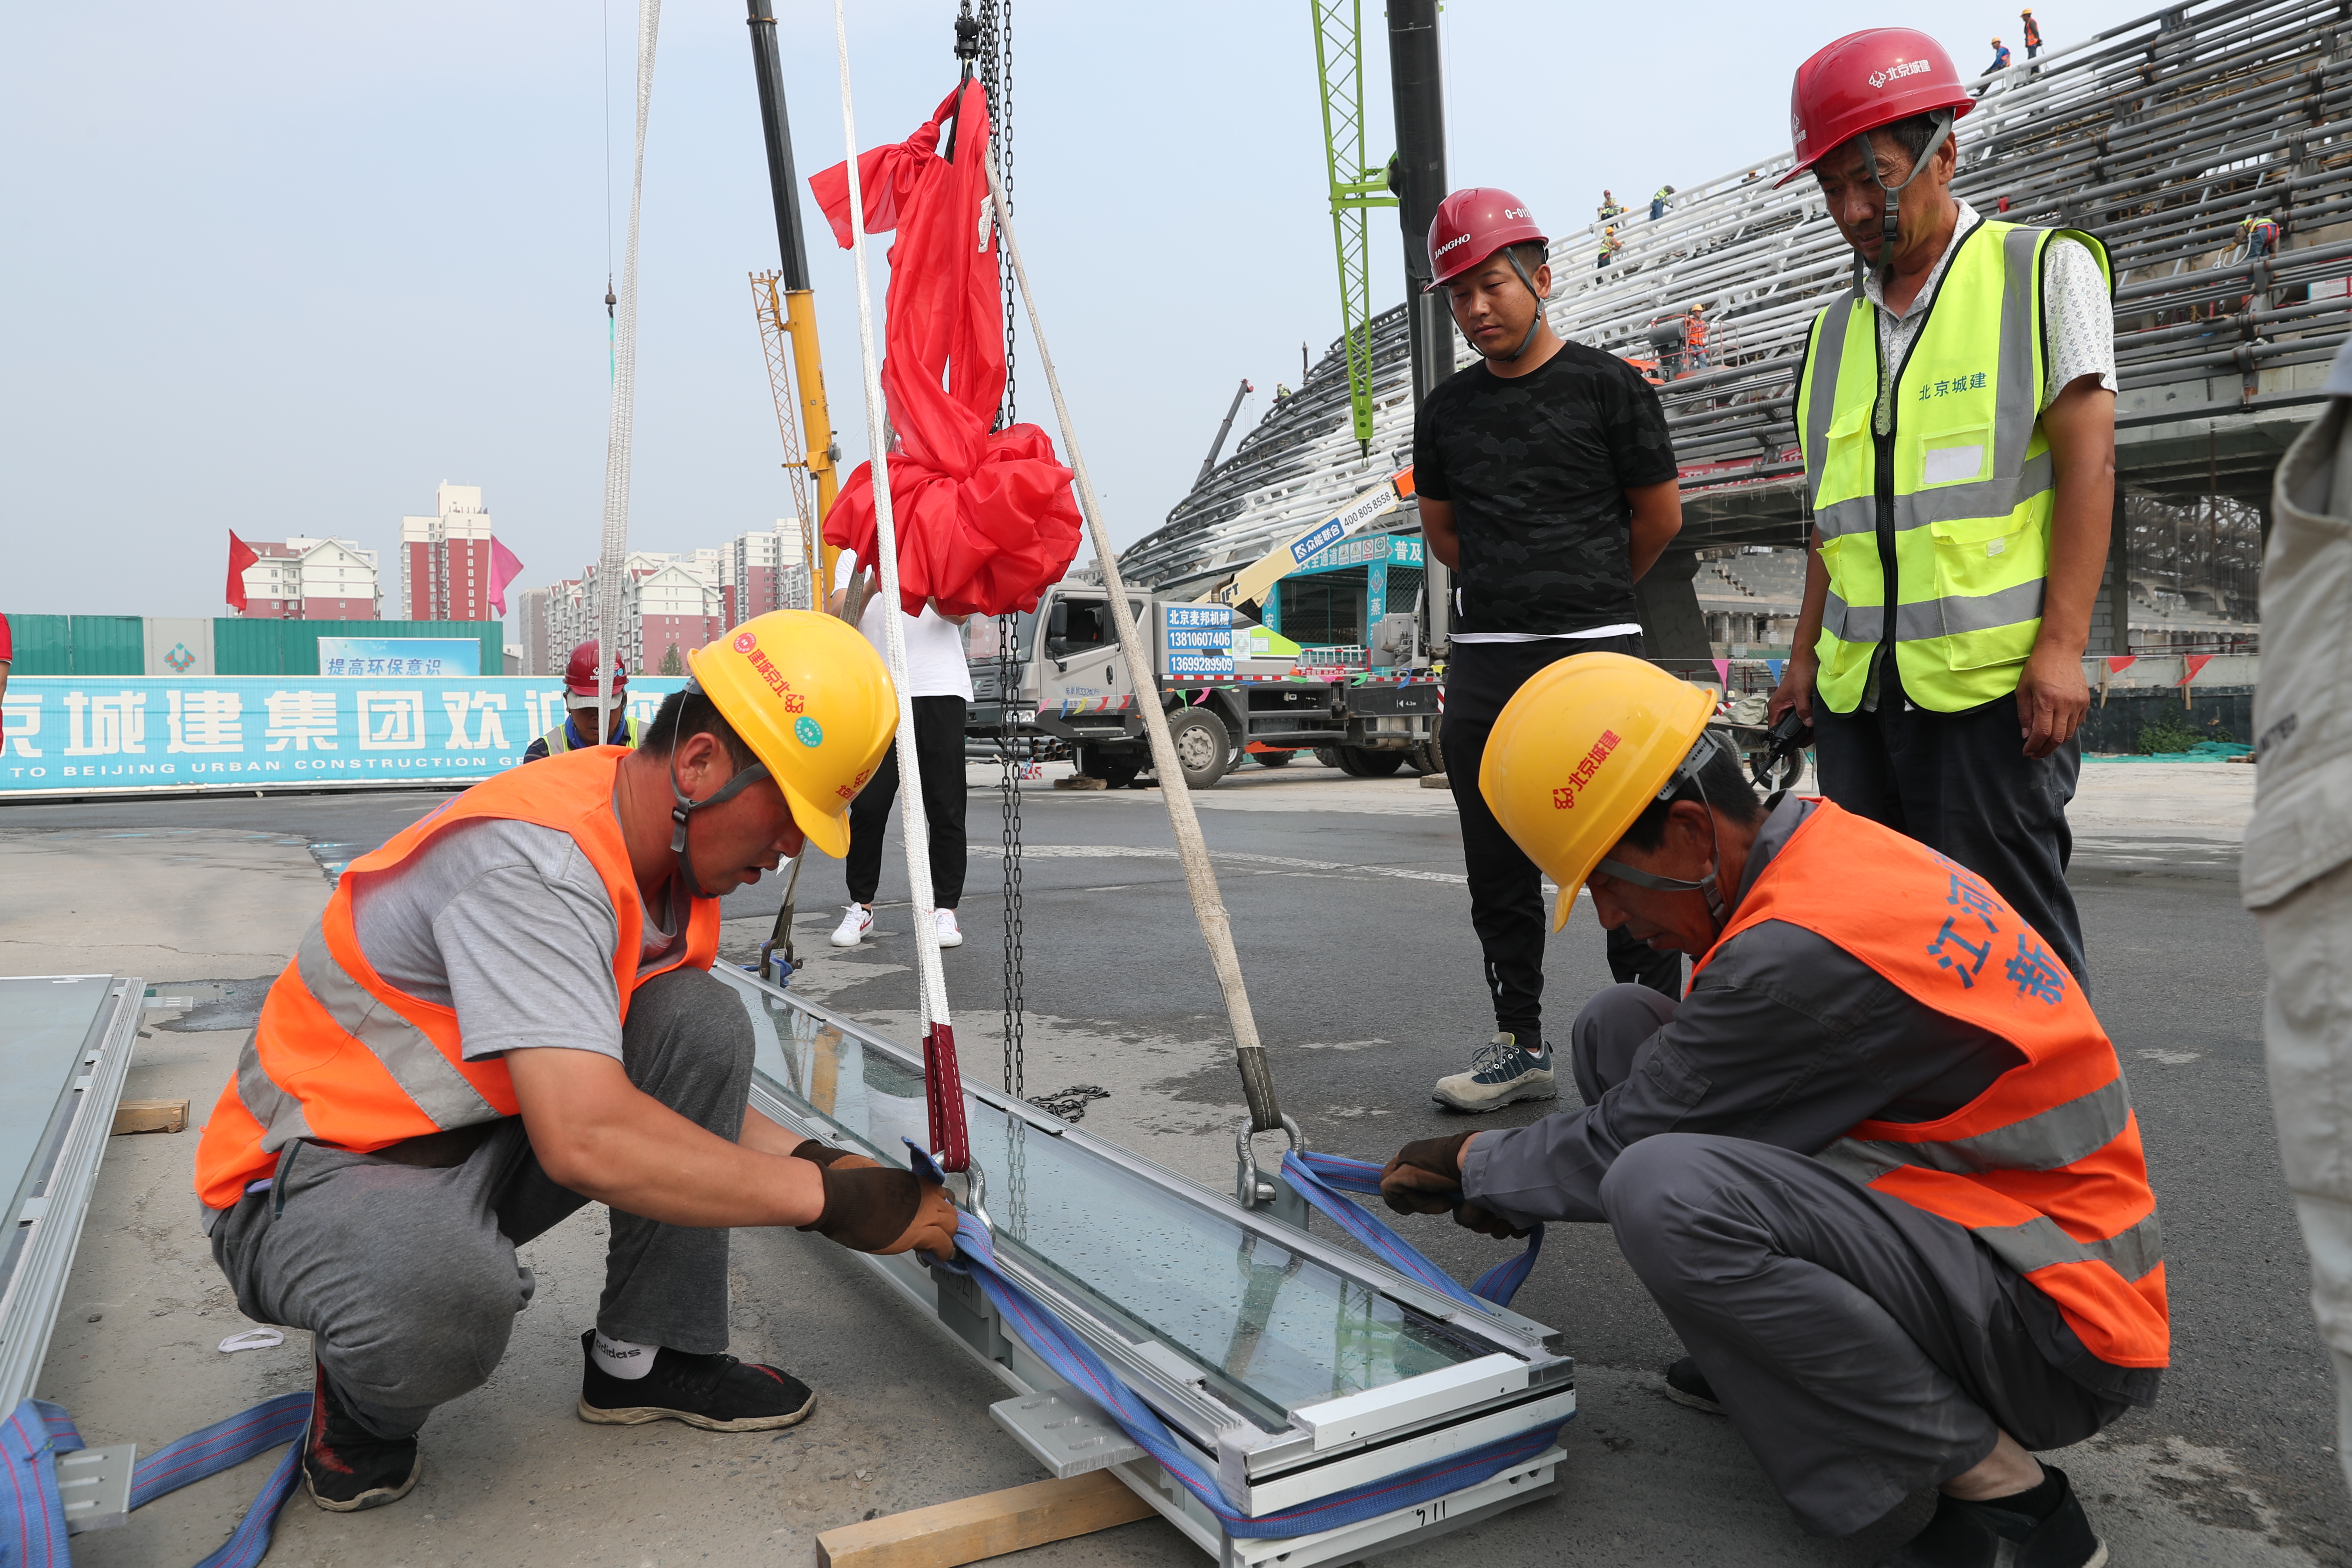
[687,609,898,861]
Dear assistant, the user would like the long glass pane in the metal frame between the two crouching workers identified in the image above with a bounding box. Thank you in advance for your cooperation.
[734,987,1494,1432]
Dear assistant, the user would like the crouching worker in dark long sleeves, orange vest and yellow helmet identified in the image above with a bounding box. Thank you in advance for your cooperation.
[1381,653,2171,1568]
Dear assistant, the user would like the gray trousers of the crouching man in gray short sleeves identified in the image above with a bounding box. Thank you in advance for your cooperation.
[211,968,753,1436]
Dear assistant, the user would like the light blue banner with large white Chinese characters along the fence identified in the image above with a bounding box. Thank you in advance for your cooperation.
[0,677,684,802]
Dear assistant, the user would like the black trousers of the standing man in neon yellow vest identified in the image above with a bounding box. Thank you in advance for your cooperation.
[1813,682,2091,987]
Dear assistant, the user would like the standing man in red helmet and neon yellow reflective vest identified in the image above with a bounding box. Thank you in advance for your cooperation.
[1771,28,2114,980]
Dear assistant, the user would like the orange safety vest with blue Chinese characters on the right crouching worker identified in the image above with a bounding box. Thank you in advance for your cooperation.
[1691,802,2171,1366]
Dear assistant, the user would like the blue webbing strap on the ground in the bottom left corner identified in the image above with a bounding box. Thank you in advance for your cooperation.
[0,1389,310,1568]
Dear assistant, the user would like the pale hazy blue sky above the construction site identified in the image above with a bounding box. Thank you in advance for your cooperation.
[0,0,2145,616]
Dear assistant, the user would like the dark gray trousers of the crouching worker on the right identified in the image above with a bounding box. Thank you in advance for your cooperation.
[1574,985,2131,1535]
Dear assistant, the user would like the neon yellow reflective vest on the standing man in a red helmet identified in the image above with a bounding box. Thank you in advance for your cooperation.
[1797,221,2112,712]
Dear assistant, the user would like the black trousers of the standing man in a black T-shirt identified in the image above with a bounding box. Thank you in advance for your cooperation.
[1439,635,1681,1044]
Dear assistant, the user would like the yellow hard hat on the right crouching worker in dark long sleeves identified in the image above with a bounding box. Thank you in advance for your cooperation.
[1477,653,1717,931]
